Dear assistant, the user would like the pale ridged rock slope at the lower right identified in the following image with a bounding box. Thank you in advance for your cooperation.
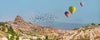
[63,25,100,40]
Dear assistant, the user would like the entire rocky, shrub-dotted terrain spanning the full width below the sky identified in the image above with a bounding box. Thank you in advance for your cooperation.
[0,16,100,40]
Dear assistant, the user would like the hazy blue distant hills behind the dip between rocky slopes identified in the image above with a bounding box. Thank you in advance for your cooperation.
[0,14,100,30]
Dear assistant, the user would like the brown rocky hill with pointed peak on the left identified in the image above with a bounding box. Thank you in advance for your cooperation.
[0,15,68,38]
